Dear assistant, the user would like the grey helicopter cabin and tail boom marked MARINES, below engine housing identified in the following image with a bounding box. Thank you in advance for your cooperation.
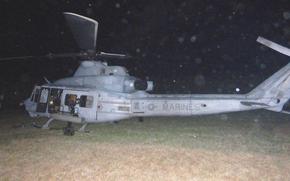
[25,85,267,123]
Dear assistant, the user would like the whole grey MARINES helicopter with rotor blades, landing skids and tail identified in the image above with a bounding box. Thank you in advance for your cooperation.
[2,12,290,135]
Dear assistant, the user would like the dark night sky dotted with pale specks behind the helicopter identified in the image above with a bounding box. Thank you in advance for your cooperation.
[0,0,290,106]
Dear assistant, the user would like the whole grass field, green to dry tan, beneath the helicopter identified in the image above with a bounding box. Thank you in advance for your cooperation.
[0,111,290,180]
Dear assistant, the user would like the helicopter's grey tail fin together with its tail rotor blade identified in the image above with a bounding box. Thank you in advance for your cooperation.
[248,37,290,112]
